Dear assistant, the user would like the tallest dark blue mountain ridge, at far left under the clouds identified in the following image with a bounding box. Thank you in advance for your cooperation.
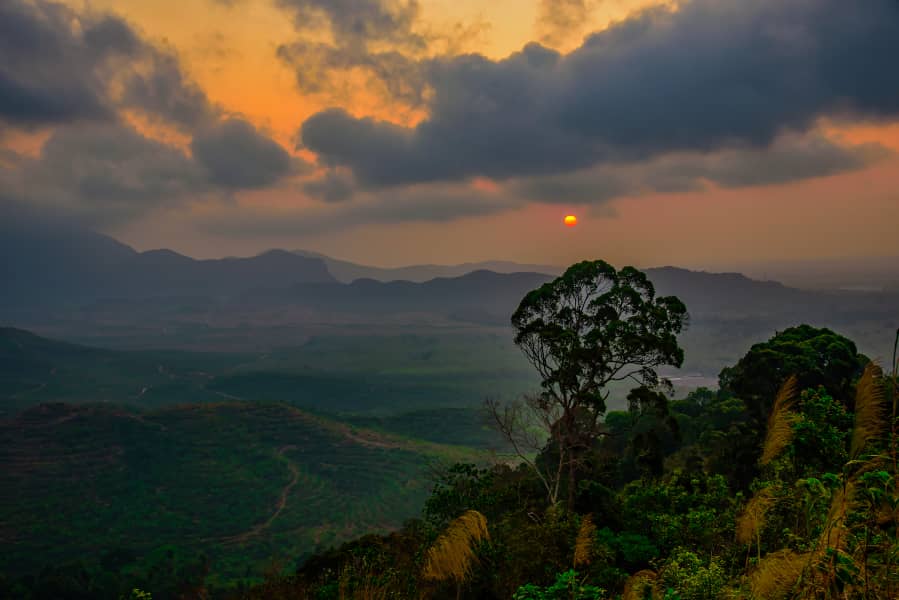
[0,222,336,306]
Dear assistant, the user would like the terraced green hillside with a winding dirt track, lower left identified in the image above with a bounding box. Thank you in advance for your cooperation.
[0,402,470,584]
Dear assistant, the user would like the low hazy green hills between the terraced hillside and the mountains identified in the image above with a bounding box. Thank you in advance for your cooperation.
[0,328,534,420]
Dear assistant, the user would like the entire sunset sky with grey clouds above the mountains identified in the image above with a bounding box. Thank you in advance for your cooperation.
[0,0,899,267]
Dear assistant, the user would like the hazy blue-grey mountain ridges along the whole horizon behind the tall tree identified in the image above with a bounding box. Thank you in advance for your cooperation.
[0,218,897,352]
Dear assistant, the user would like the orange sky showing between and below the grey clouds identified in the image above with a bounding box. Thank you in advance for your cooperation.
[29,0,899,265]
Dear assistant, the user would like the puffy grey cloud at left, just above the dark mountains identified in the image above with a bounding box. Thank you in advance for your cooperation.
[0,119,308,227]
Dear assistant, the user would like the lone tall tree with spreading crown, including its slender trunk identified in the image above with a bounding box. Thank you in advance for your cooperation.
[489,260,688,509]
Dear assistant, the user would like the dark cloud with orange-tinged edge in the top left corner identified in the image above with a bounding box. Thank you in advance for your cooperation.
[0,0,216,129]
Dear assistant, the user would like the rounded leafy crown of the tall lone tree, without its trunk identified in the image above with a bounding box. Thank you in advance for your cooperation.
[512,260,687,414]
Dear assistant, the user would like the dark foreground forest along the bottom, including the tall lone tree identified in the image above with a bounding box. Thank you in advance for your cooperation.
[0,261,899,600]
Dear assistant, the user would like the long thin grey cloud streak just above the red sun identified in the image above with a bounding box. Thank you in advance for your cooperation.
[195,129,889,239]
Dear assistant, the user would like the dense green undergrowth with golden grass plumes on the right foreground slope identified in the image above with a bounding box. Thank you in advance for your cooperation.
[234,326,899,600]
